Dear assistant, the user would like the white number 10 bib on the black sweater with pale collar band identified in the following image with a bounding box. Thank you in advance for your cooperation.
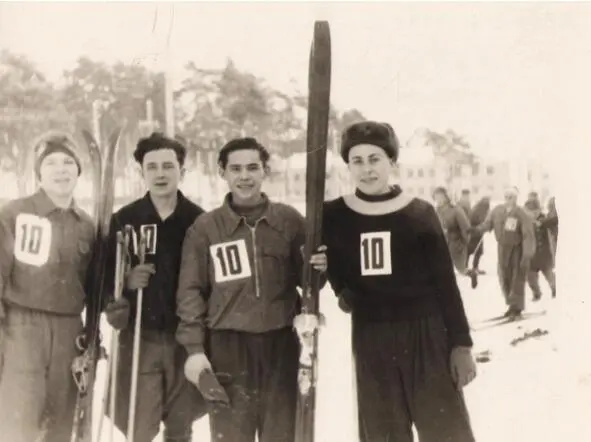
[360,232,392,276]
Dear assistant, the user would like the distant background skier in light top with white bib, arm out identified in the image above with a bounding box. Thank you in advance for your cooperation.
[473,187,536,319]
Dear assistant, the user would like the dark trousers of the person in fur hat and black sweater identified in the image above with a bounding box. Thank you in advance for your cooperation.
[352,316,475,442]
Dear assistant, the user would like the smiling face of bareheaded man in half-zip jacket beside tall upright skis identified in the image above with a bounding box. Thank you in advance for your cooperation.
[220,149,268,205]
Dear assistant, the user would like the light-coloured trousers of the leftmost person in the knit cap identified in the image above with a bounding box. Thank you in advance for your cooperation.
[0,306,82,442]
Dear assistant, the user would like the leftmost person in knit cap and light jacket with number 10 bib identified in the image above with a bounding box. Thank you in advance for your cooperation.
[0,137,94,442]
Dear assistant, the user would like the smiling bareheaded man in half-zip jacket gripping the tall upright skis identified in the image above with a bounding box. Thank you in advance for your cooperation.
[177,138,326,442]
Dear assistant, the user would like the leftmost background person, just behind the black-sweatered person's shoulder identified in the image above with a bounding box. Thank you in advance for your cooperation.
[433,187,470,274]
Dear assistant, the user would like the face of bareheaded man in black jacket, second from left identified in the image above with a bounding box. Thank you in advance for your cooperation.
[142,149,184,197]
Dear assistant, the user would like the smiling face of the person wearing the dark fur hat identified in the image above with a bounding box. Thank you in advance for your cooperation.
[349,144,394,195]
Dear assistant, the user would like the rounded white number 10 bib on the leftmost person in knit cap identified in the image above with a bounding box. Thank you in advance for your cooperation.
[14,213,51,267]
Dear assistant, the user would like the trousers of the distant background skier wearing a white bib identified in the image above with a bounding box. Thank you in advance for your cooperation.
[498,245,529,311]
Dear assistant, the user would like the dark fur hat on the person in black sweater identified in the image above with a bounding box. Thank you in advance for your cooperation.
[341,121,400,164]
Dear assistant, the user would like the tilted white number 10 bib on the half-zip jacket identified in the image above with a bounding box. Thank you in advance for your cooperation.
[209,239,252,282]
